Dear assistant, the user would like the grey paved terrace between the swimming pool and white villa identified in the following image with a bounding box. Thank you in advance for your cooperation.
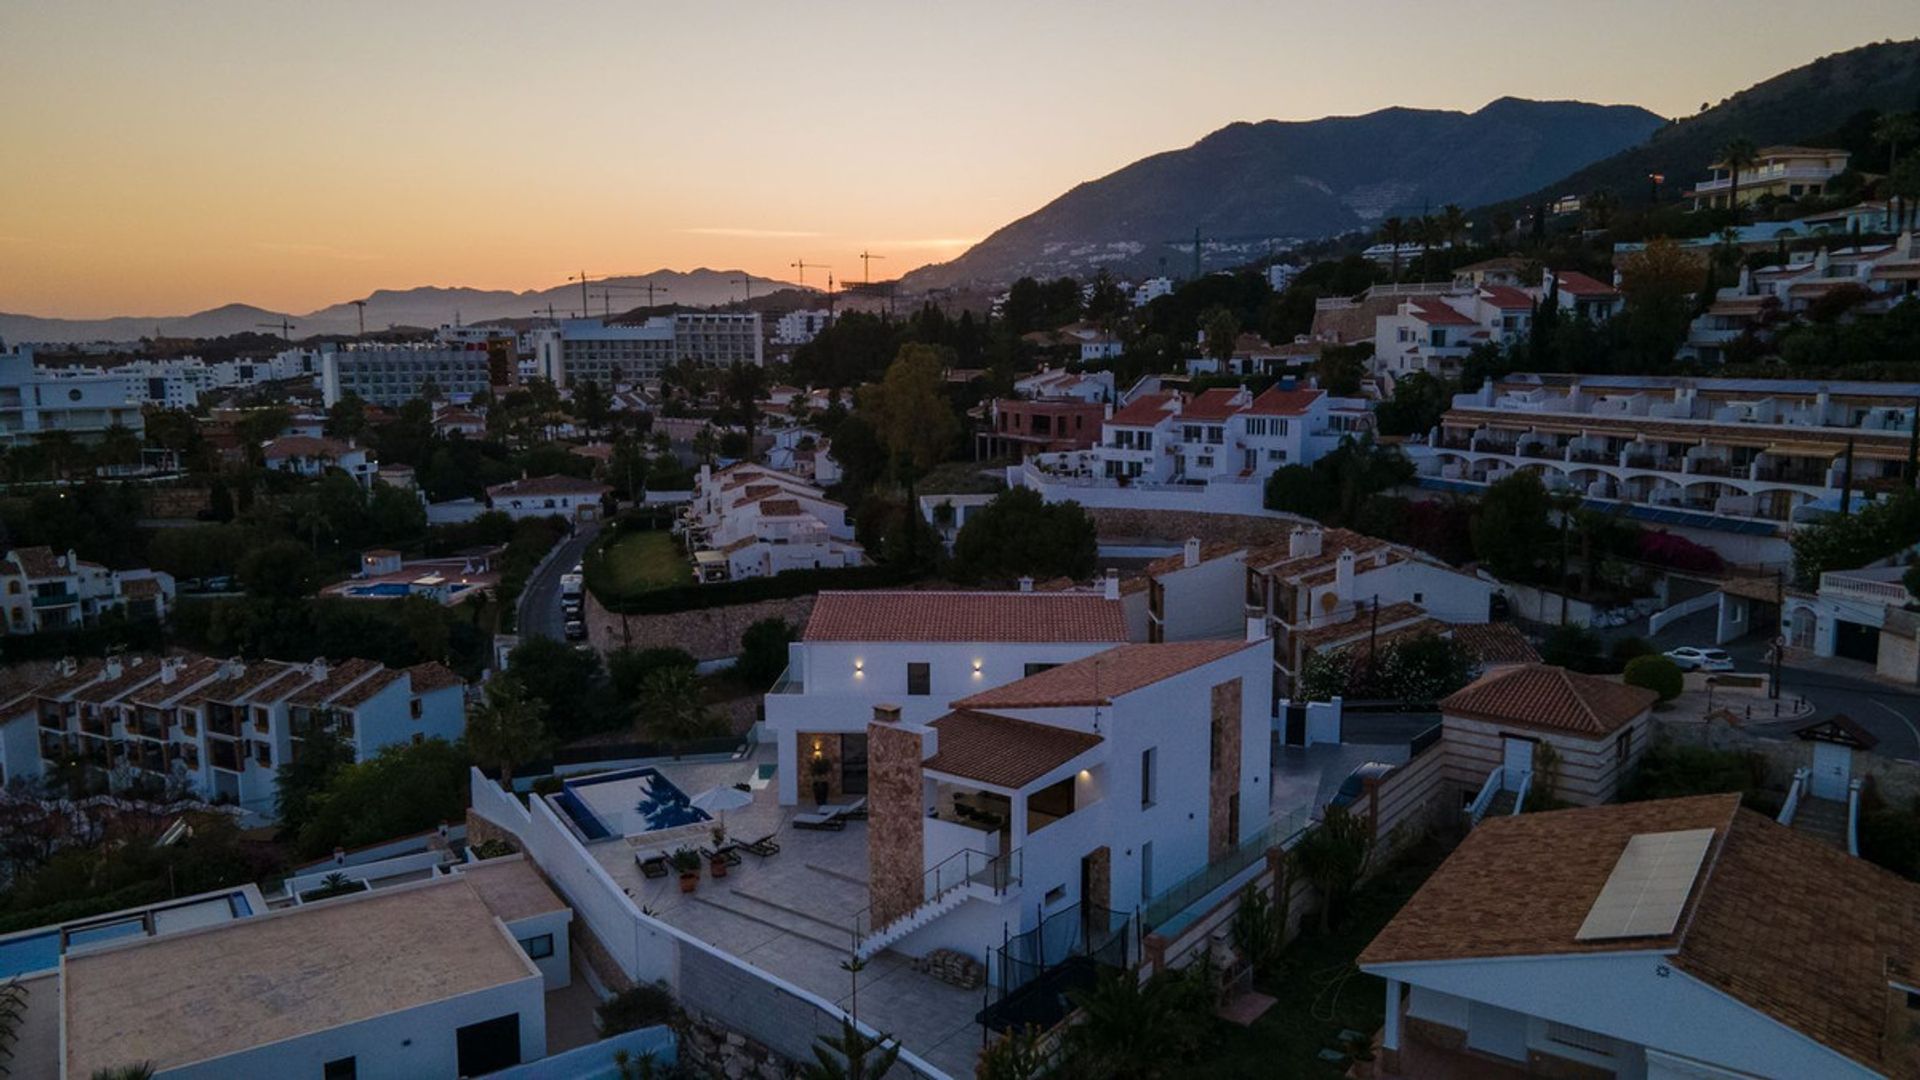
[588,759,981,1076]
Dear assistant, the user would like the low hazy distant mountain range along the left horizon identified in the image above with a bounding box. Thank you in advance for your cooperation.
[0,267,797,344]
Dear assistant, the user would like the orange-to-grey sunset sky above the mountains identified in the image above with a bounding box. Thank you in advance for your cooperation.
[0,0,1920,317]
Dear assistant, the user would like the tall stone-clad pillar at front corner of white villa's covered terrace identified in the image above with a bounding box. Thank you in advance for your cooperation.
[866,705,927,930]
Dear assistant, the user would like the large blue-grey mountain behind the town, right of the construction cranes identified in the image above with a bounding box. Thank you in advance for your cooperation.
[902,98,1665,288]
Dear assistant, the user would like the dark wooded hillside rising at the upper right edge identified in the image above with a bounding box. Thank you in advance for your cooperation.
[1489,40,1920,216]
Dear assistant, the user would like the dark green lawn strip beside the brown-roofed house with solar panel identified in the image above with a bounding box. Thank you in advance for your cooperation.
[1198,840,1446,1080]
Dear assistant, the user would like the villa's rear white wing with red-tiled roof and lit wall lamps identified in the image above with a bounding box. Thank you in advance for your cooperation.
[766,582,1127,805]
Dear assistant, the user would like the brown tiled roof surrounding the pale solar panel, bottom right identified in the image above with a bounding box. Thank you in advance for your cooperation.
[1359,794,1920,1076]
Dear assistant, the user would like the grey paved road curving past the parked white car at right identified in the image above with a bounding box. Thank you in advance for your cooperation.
[1653,613,1920,761]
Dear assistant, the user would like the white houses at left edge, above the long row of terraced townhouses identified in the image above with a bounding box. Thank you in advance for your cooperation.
[0,546,175,634]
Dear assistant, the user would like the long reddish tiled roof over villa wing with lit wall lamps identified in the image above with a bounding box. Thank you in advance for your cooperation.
[801,590,1127,642]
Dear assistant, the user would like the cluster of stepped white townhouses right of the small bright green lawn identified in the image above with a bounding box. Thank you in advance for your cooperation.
[682,461,866,582]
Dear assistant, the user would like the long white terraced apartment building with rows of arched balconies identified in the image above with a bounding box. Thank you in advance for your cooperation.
[1415,375,1920,561]
